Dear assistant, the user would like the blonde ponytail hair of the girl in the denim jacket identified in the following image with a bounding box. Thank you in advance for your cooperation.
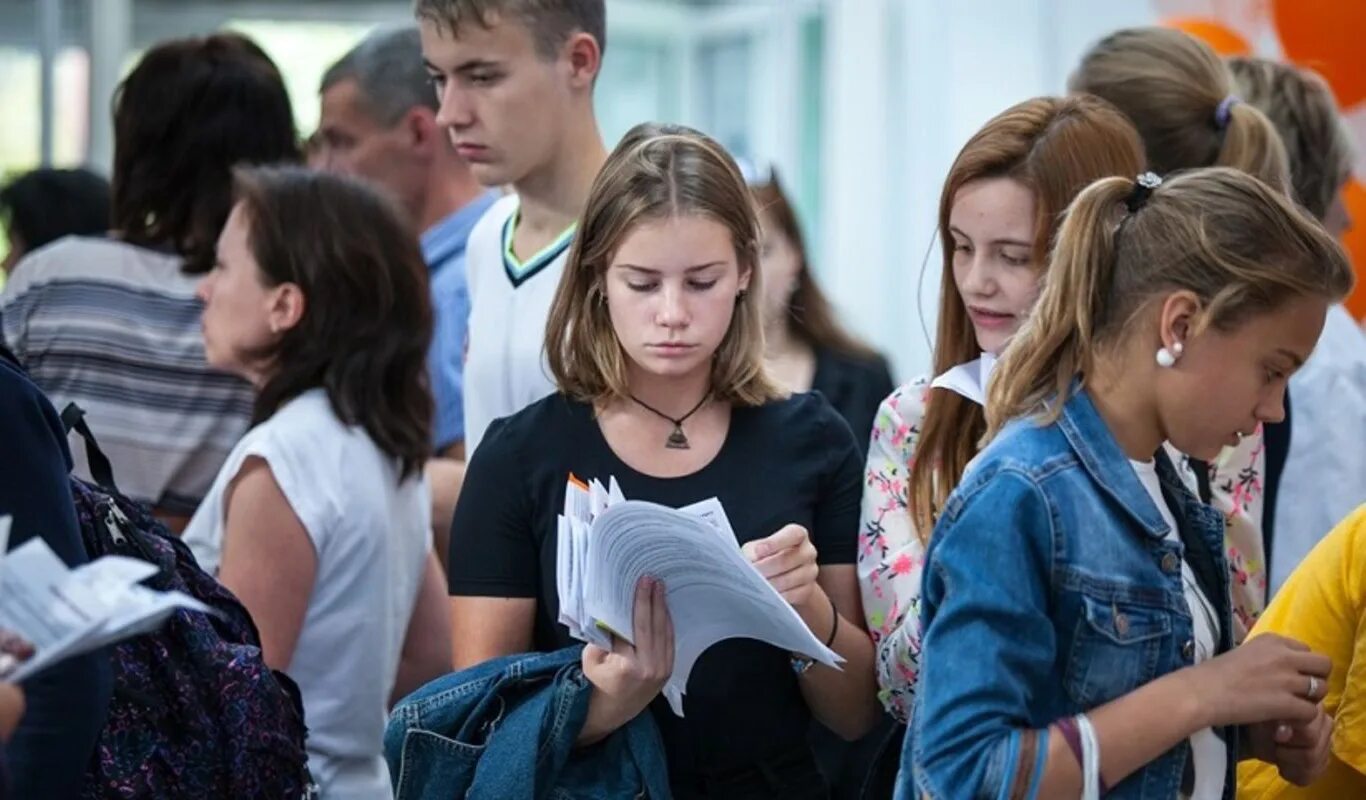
[986,168,1352,437]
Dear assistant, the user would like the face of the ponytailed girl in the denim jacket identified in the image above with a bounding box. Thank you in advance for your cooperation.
[1158,292,1328,460]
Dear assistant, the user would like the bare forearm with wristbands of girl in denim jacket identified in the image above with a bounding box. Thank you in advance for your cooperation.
[1025,670,1208,797]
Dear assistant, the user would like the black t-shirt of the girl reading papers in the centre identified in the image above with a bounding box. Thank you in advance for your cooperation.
[448,395,863,782]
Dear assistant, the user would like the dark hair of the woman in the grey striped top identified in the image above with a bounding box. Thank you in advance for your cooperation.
[111,33,299,274]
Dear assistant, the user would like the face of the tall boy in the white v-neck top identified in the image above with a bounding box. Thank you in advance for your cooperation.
[421,16,581,186]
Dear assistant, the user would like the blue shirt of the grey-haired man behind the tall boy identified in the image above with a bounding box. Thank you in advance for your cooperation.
[422,191,499,451]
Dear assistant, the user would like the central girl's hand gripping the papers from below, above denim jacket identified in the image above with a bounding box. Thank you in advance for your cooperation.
[578,577,673,745]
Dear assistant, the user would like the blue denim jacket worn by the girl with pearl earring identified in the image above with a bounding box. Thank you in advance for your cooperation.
[902,389,1238,800]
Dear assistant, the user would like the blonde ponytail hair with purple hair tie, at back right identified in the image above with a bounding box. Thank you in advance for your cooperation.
[1068,27,1290,191]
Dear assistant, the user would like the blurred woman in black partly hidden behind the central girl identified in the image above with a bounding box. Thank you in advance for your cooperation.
[750,171,896,455]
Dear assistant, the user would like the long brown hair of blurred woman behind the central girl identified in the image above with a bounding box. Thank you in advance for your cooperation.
[750,172,877,359]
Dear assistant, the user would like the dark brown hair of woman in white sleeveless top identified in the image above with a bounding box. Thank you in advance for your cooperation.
[235,167,433,479]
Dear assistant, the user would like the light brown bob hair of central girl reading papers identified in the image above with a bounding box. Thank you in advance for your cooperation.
[545,123,783,407]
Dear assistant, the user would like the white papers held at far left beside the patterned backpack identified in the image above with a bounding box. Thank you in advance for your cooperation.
[0,517,210,681]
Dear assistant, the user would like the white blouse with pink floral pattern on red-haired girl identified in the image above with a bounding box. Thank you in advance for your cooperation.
[858,378,1266,721]
